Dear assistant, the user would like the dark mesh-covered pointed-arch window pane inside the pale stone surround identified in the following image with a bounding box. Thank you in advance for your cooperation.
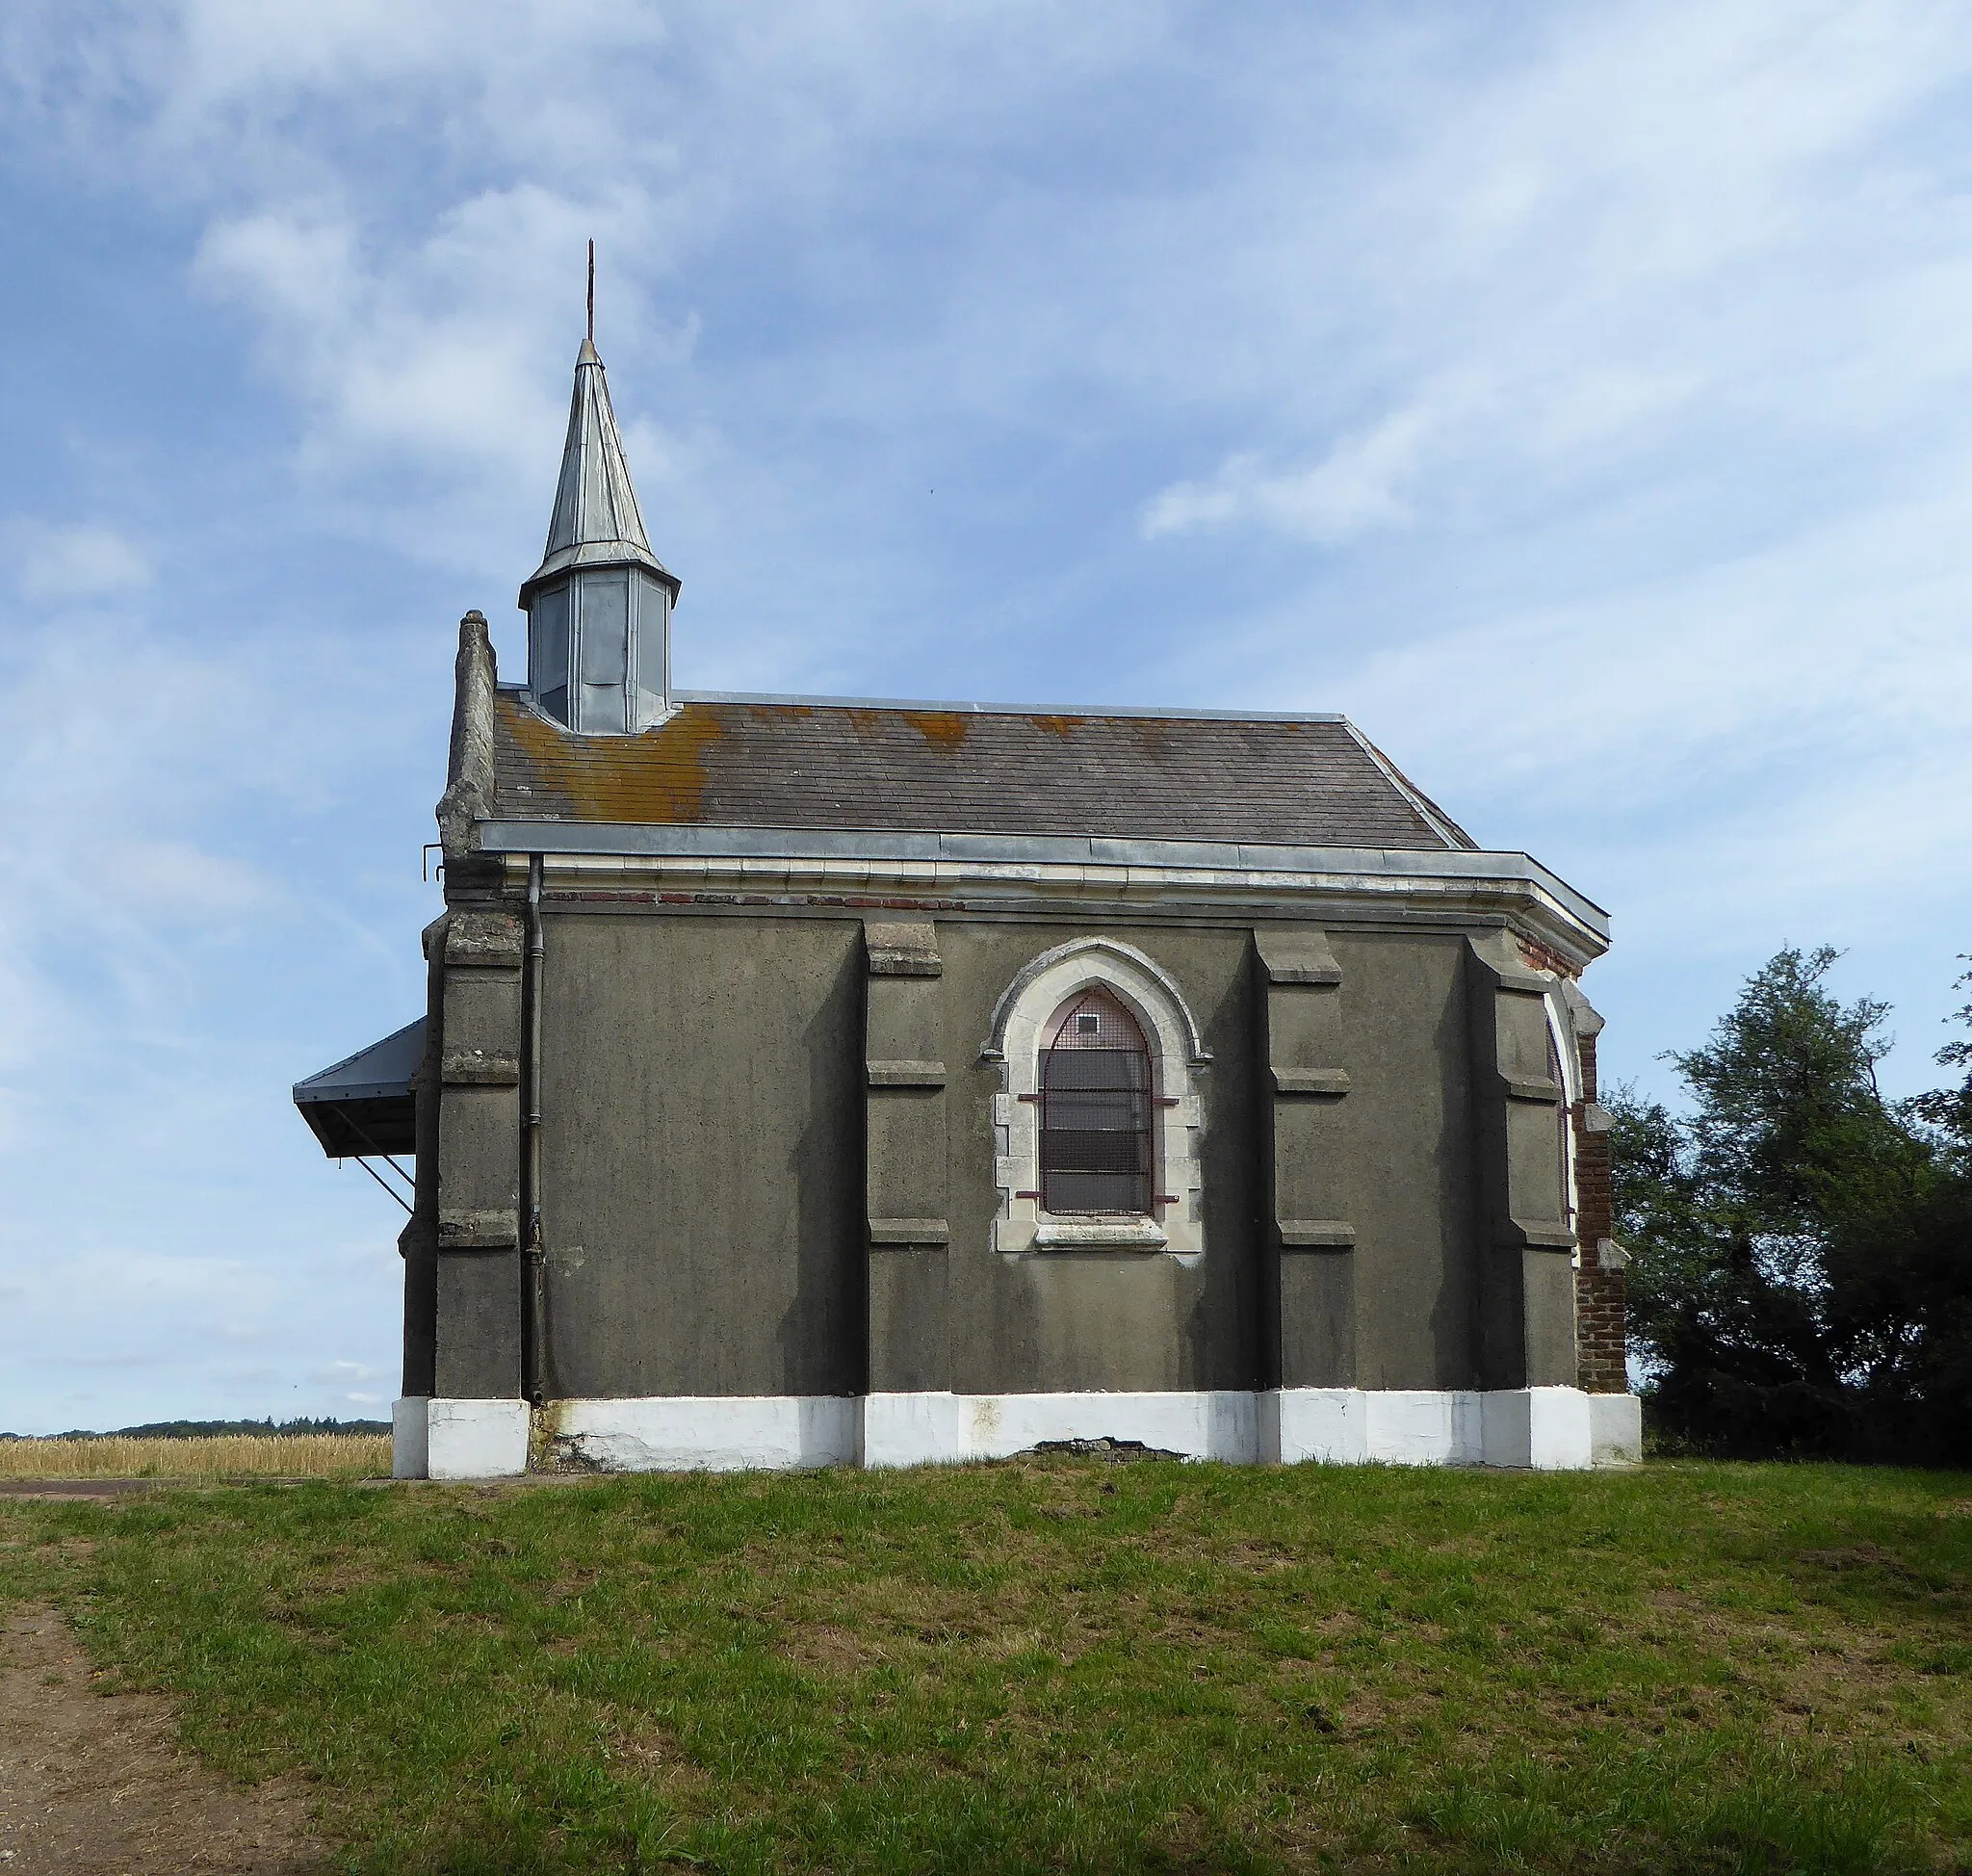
[1041,984,1155,1217]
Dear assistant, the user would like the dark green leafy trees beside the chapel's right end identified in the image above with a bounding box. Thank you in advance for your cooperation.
[1611,947,1972,1458]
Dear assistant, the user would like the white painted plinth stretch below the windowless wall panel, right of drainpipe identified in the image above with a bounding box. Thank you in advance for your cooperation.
[550,1394,862,1472]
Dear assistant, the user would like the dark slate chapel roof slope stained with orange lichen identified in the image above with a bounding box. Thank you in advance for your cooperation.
[493,689,1473,850]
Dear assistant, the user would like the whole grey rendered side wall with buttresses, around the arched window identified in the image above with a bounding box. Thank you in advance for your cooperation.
[420,907,1573,1398]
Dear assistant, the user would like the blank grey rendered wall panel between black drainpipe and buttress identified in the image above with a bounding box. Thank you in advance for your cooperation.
[540,911,864,1398]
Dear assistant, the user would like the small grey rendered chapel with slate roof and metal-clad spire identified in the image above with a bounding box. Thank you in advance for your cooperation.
[294,341,1641,1479]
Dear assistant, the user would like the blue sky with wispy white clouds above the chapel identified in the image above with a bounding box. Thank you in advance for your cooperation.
[0,0,1972,1432]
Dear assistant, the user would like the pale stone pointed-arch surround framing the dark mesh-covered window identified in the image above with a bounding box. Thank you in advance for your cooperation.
[980,937,1210,1264]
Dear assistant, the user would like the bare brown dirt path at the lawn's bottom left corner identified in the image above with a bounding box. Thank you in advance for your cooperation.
[0,1607,325,1876]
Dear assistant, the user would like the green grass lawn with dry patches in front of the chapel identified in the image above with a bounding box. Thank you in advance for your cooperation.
[0,1460,1972,1872]
